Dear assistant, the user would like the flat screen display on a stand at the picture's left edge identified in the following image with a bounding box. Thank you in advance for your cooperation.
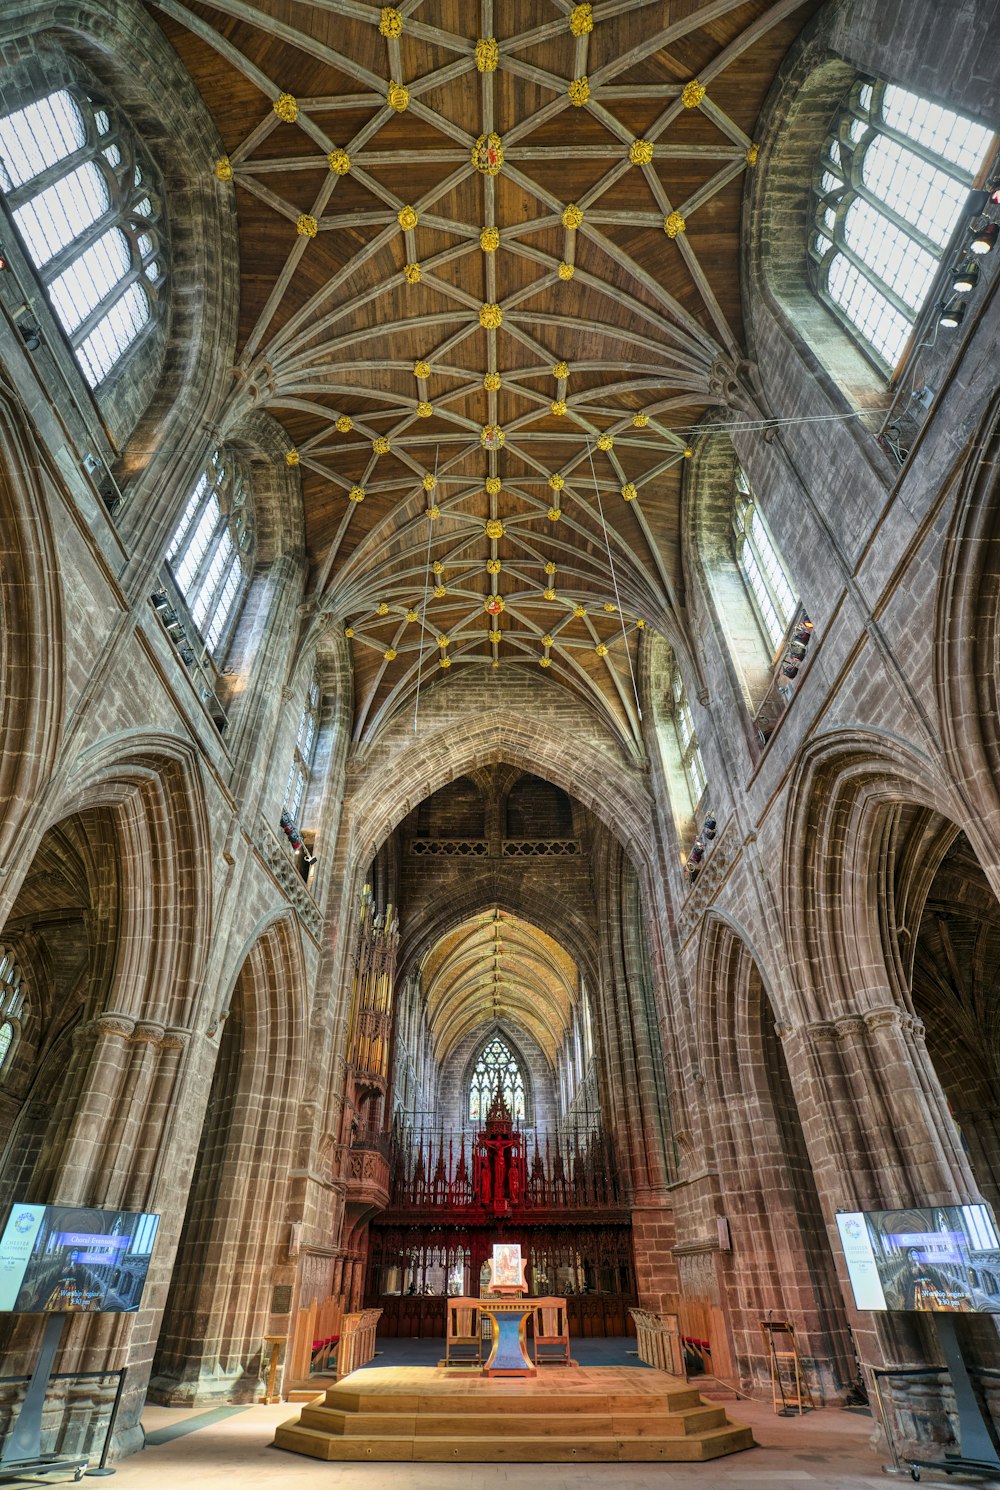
[0,1204,159,1314]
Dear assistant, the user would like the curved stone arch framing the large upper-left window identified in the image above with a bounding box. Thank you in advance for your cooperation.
[3,0,237,461]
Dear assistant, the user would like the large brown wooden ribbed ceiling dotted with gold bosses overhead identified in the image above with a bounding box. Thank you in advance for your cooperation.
[149,0,815,746]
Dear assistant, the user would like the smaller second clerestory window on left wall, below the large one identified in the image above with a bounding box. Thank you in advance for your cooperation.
[167,450,253,662]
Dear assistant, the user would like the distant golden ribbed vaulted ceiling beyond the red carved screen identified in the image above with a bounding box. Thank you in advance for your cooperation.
[420,910,580,1065]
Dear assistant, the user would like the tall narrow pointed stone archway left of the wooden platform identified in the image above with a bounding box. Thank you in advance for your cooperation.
[151,913,306,1405]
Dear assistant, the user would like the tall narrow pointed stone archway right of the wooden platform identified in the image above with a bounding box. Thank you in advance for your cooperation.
[696,912,854,1390]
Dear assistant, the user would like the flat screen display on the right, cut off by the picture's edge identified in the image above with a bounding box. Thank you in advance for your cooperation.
[838,1204,1000,1314]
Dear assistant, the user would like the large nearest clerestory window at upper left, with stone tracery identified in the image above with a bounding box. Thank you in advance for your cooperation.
[0,86,167,389]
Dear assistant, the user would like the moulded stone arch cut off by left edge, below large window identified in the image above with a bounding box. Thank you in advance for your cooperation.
[0,378,64,863]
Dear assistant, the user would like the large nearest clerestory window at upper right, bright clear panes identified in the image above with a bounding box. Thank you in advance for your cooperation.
[809,79,996,375]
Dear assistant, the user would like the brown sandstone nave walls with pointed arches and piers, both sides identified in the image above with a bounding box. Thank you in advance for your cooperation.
[0,0,1000,1448]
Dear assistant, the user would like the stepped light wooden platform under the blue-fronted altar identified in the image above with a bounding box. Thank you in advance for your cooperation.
[274,1366,754,1463]
